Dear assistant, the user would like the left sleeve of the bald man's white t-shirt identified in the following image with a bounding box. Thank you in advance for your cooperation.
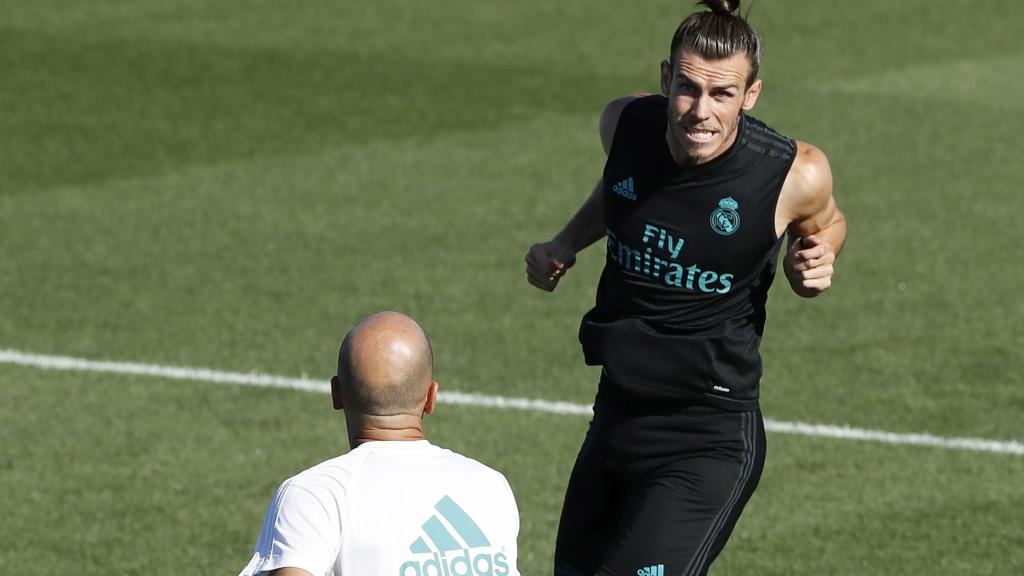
[239,480,341,576]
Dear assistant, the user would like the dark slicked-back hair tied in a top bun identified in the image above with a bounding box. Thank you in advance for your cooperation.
[669,0,761,86]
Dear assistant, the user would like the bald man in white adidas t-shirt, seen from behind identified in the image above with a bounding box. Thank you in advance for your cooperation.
[240,312,519,576]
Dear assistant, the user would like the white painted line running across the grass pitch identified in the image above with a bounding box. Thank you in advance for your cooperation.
[0,349,1024,455]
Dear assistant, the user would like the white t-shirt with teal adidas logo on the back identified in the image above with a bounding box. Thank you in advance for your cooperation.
[239,440,519,576]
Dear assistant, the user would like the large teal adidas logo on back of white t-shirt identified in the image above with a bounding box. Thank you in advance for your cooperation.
[398,496,509,576]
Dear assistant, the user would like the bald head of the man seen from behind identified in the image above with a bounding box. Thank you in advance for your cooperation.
[338,312,433,416]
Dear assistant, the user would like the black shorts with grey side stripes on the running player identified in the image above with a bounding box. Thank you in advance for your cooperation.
[555,381,765,576]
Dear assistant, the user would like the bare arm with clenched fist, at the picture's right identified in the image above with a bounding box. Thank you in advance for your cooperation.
[775,142,846,297]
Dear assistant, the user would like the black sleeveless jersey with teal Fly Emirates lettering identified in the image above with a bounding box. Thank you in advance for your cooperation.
[580,95,797,410]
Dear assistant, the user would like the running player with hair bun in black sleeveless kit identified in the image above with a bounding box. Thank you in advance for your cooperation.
[526,0,846,576]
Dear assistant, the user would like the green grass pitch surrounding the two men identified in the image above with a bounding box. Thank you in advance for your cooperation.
[0,0,1024,576]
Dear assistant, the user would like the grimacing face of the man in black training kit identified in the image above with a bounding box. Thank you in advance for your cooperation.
[662,50,761,164]
